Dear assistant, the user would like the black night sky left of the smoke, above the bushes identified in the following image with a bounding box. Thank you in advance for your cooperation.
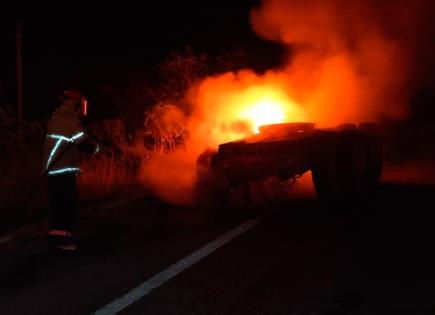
[0,0,280,119]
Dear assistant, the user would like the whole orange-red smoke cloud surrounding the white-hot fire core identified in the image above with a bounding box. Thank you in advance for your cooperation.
[143,0,435,204]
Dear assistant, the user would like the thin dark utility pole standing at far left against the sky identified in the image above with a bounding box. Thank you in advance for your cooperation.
[16,21,24,146]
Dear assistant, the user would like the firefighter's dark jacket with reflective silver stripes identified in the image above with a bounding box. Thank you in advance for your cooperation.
[43,104,89,176]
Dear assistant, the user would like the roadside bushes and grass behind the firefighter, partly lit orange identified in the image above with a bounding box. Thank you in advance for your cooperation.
[0,48,215,224]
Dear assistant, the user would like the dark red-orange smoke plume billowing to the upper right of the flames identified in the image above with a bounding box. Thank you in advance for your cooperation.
[251,0,434,124]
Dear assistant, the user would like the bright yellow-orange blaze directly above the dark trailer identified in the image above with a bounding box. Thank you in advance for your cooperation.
[189,70,307,147]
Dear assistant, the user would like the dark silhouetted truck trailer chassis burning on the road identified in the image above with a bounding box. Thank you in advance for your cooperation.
[197,122,382,204]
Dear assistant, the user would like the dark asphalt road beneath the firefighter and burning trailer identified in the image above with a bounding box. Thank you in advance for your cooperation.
[0,180,435,315]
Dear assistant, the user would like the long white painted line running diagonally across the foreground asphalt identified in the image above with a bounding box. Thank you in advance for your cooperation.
[93,220,260,315]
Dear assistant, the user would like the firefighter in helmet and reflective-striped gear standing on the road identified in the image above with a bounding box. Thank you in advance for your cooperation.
[43,90,99,251]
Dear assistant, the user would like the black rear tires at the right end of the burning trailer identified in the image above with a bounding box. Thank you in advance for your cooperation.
[311,123,382,207]
